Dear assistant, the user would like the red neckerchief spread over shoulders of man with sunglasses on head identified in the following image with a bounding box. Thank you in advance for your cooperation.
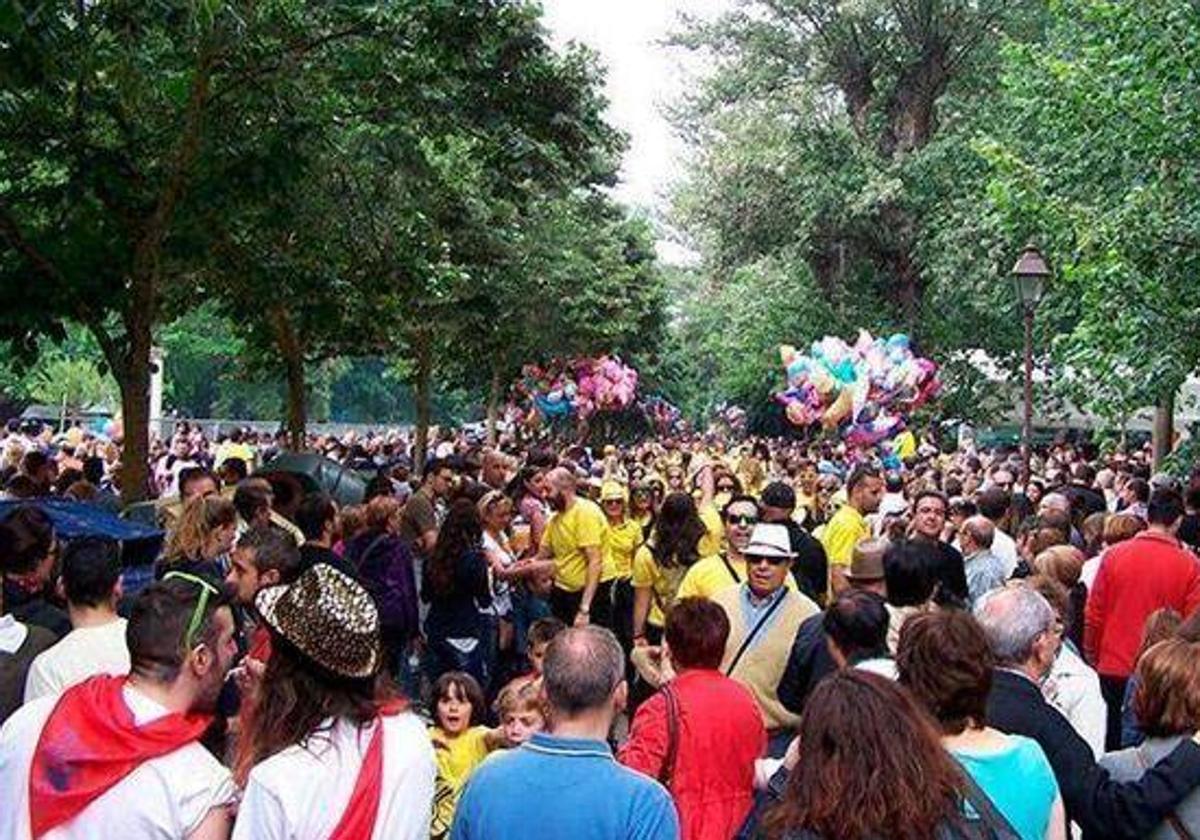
[29,676,212,839]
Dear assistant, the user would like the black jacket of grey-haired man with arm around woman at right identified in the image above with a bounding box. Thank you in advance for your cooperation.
[988,670,1200,840]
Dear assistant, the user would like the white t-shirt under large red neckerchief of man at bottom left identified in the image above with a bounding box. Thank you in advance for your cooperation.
[0,686,234,840]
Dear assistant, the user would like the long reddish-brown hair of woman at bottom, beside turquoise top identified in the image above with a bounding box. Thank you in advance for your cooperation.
[766,670,965,840]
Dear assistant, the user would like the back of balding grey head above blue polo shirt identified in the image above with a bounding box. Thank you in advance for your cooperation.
[542,625,625,718]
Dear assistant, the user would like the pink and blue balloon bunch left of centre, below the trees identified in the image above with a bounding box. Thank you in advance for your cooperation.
[514,355,637,420]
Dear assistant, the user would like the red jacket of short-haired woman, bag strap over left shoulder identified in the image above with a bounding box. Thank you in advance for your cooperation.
[618,671,767,840]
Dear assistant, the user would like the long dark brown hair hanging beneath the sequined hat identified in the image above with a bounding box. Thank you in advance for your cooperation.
[234,632,403,785]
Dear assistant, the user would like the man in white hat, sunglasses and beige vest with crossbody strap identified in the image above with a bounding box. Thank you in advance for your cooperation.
[713,523,820,757]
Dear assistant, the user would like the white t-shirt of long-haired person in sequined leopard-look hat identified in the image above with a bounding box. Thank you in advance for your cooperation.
[233,712,436,840]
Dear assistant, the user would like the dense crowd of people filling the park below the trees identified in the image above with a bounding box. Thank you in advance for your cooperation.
[0,415,1200,840]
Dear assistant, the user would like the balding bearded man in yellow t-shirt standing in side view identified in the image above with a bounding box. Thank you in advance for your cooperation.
[538,467,612,626]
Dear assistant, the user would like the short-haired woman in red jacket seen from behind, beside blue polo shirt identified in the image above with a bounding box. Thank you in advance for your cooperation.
[618,598,767,840]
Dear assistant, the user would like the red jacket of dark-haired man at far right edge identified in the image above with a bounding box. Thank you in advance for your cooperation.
[1084,530,1200,677]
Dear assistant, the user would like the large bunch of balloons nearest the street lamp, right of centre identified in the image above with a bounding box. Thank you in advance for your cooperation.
[775,330,941,446]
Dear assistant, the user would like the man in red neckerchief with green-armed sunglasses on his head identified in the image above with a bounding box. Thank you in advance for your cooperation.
[0,572,238,840]
